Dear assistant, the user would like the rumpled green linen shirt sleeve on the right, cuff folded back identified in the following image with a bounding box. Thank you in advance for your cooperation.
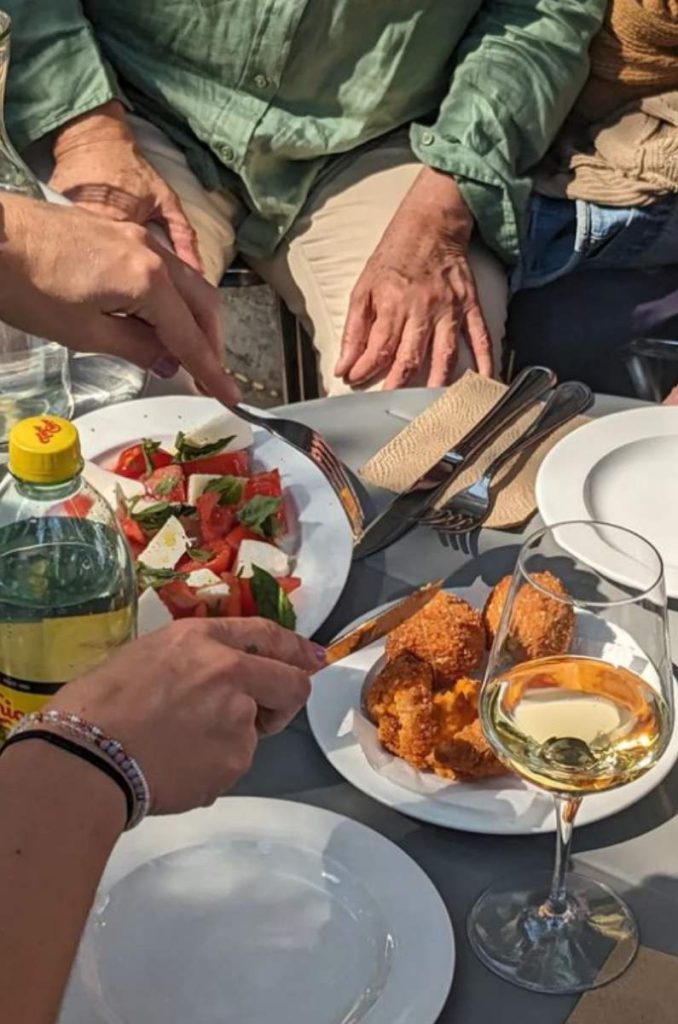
[412,0,605,262]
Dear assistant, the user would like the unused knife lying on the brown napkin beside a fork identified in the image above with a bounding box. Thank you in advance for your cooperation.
[353,367,557,559]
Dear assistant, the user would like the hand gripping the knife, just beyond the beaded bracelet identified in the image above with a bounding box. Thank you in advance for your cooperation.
[46,618,323,814]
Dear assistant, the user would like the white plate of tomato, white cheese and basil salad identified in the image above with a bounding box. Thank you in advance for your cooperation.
[77,396,353,636]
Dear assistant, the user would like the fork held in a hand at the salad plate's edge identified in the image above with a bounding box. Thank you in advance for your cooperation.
[228,404,365,542]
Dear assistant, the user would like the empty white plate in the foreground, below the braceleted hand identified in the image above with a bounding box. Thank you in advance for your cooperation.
[59,797,455,1024]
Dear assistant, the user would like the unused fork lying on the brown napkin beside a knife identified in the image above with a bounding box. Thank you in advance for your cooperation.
[419,381,593,536]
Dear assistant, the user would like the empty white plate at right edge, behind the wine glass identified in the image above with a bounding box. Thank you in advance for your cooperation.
[537,406,678,597]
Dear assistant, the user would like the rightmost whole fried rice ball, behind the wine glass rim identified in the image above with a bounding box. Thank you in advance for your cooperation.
[482,571,575,662]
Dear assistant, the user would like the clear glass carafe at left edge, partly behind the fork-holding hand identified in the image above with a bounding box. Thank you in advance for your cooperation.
[0,10,73,458]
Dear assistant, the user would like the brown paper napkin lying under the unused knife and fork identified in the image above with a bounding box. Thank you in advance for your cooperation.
[359,370,587,529]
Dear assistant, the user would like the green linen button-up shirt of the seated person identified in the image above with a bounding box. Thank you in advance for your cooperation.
[2,0,606,263]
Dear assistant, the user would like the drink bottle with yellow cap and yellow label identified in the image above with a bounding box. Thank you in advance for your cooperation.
[0,416,136,743]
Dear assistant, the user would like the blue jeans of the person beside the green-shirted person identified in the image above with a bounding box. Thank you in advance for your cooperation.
[518,195,678,292]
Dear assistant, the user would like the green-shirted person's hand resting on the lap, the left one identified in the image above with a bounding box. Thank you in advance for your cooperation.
[49,100,203,270]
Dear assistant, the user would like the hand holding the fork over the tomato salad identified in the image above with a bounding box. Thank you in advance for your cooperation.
[0,194,240,404]
